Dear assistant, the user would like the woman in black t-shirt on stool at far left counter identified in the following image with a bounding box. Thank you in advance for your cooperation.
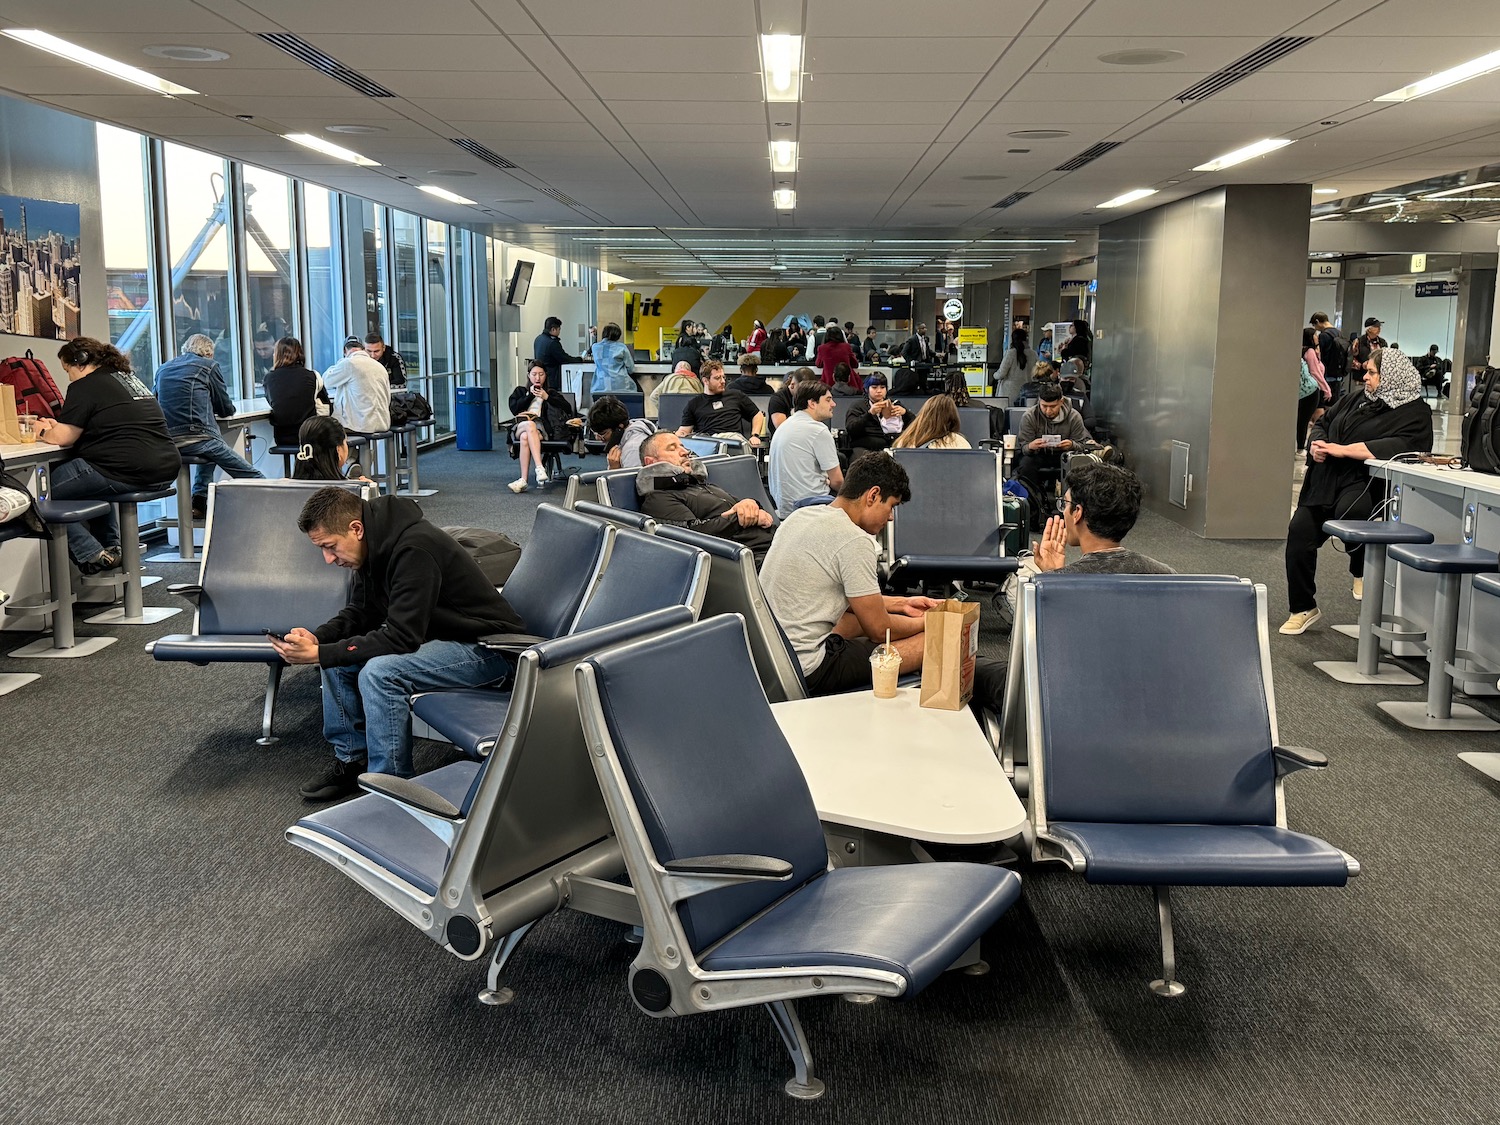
[39,336,182,575]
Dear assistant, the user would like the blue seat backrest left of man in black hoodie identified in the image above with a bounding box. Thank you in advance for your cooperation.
[197,480,360,636]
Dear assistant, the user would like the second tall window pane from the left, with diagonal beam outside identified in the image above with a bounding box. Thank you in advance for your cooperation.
[164,144,235,390]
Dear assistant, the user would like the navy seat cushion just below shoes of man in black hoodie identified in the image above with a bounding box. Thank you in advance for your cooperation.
[297,762,480,894]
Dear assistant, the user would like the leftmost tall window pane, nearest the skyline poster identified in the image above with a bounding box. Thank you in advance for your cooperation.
[94,125,161,386]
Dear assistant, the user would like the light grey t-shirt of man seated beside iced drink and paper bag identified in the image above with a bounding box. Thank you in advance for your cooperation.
[761,507,881,675]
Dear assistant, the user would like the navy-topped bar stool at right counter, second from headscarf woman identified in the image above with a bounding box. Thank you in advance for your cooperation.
[1379,543,1500,731]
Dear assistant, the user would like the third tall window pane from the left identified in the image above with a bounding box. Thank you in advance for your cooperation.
[243,165,299,395]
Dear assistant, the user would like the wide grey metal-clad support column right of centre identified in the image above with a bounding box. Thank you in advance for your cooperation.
[1094,185,1311,539]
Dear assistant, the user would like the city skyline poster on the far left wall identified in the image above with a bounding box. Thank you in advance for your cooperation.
[0,195,81,341]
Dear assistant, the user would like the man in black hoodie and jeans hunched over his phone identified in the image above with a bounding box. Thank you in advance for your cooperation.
[272,488,524,801]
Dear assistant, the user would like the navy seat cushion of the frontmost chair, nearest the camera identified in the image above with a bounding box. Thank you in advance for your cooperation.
[699,863,1022,996]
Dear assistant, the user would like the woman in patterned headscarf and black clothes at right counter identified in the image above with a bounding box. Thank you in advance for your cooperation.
[1281,348,1433,635]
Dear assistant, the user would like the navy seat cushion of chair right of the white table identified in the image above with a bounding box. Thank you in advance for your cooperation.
[1049,821,1349,887]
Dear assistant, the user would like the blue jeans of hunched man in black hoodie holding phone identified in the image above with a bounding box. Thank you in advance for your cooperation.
[323,641,512,777]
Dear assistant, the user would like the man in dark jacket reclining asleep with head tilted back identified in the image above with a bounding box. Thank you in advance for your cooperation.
[636,431,776,567]
